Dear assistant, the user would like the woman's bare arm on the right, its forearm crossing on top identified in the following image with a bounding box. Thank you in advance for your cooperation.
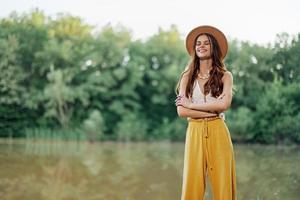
[188,71,233,112]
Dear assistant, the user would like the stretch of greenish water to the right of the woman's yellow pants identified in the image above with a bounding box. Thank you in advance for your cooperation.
[236,145,300,200]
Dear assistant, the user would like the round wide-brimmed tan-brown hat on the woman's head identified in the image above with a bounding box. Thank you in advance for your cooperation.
[185,25,228,60]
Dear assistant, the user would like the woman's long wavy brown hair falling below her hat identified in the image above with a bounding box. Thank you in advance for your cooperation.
[176,33,226,98]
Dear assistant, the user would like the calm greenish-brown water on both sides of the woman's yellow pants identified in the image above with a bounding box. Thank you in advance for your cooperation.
[0,140,300,200]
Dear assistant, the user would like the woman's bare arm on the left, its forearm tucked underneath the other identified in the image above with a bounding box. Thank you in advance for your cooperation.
[177,73,216,118]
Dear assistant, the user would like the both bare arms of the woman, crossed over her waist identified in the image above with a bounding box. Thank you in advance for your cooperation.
[176,71,233,118]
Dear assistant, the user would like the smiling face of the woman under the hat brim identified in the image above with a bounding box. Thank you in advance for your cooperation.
[195,35,211,60]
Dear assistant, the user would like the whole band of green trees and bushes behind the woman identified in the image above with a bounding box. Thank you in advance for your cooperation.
[0,10,300,143]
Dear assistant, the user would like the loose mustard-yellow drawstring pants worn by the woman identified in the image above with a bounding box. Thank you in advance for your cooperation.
[181,118,237,200]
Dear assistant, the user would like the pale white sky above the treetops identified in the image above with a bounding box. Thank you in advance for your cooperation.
[0,0,300,44]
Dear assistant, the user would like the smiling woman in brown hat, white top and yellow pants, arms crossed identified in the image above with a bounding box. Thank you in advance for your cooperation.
[175,26,237,200]
